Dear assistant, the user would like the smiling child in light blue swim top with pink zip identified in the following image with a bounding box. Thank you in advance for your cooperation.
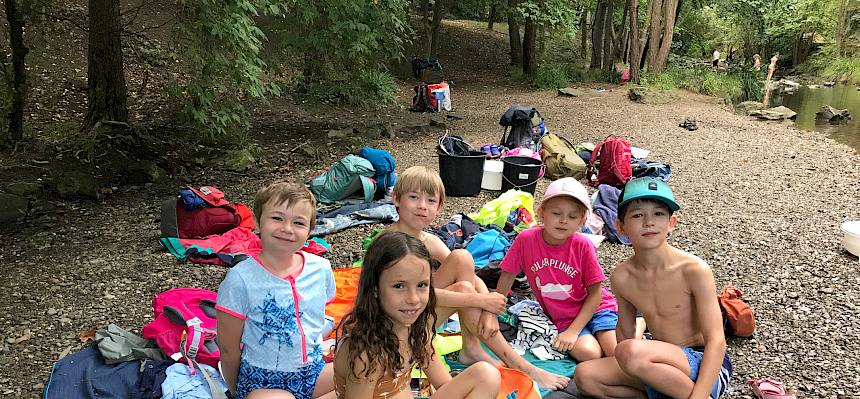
[216,182,335,399]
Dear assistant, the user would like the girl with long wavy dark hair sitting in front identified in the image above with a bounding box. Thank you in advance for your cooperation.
[334,232,501,399]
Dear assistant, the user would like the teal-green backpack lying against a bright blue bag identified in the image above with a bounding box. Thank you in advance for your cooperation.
[308,154,376,204]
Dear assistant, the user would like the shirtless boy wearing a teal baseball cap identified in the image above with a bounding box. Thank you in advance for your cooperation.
[574,177,732,399]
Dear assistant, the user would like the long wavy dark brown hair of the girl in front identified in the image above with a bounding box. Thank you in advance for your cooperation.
[337,232,436,379]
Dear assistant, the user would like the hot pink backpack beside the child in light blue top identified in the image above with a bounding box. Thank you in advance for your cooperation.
[141,288,221,373]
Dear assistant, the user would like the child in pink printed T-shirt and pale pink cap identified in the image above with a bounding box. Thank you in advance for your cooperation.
[496,177,618,362]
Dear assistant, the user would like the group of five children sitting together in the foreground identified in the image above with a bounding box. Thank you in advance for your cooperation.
[217,166,731,399]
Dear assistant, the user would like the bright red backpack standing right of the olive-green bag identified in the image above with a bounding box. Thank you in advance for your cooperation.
[585,135,633,188]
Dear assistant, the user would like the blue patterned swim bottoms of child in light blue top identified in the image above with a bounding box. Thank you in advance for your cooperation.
[236,358,325,399]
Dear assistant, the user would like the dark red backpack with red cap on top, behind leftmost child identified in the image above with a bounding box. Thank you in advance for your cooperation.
[161,186,254,239]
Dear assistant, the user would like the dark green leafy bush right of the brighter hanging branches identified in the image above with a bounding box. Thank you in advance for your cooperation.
[274,0,411,104]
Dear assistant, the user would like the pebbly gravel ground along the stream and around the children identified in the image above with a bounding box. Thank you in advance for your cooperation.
[0,21,860,398]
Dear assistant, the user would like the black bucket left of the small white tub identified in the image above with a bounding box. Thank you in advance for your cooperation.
[438,151,486,197]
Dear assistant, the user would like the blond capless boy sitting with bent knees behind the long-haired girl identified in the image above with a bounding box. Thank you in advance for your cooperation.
[386,166,570,390]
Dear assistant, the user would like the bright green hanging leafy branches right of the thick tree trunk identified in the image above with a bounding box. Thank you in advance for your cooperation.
[179,0,282,139]
